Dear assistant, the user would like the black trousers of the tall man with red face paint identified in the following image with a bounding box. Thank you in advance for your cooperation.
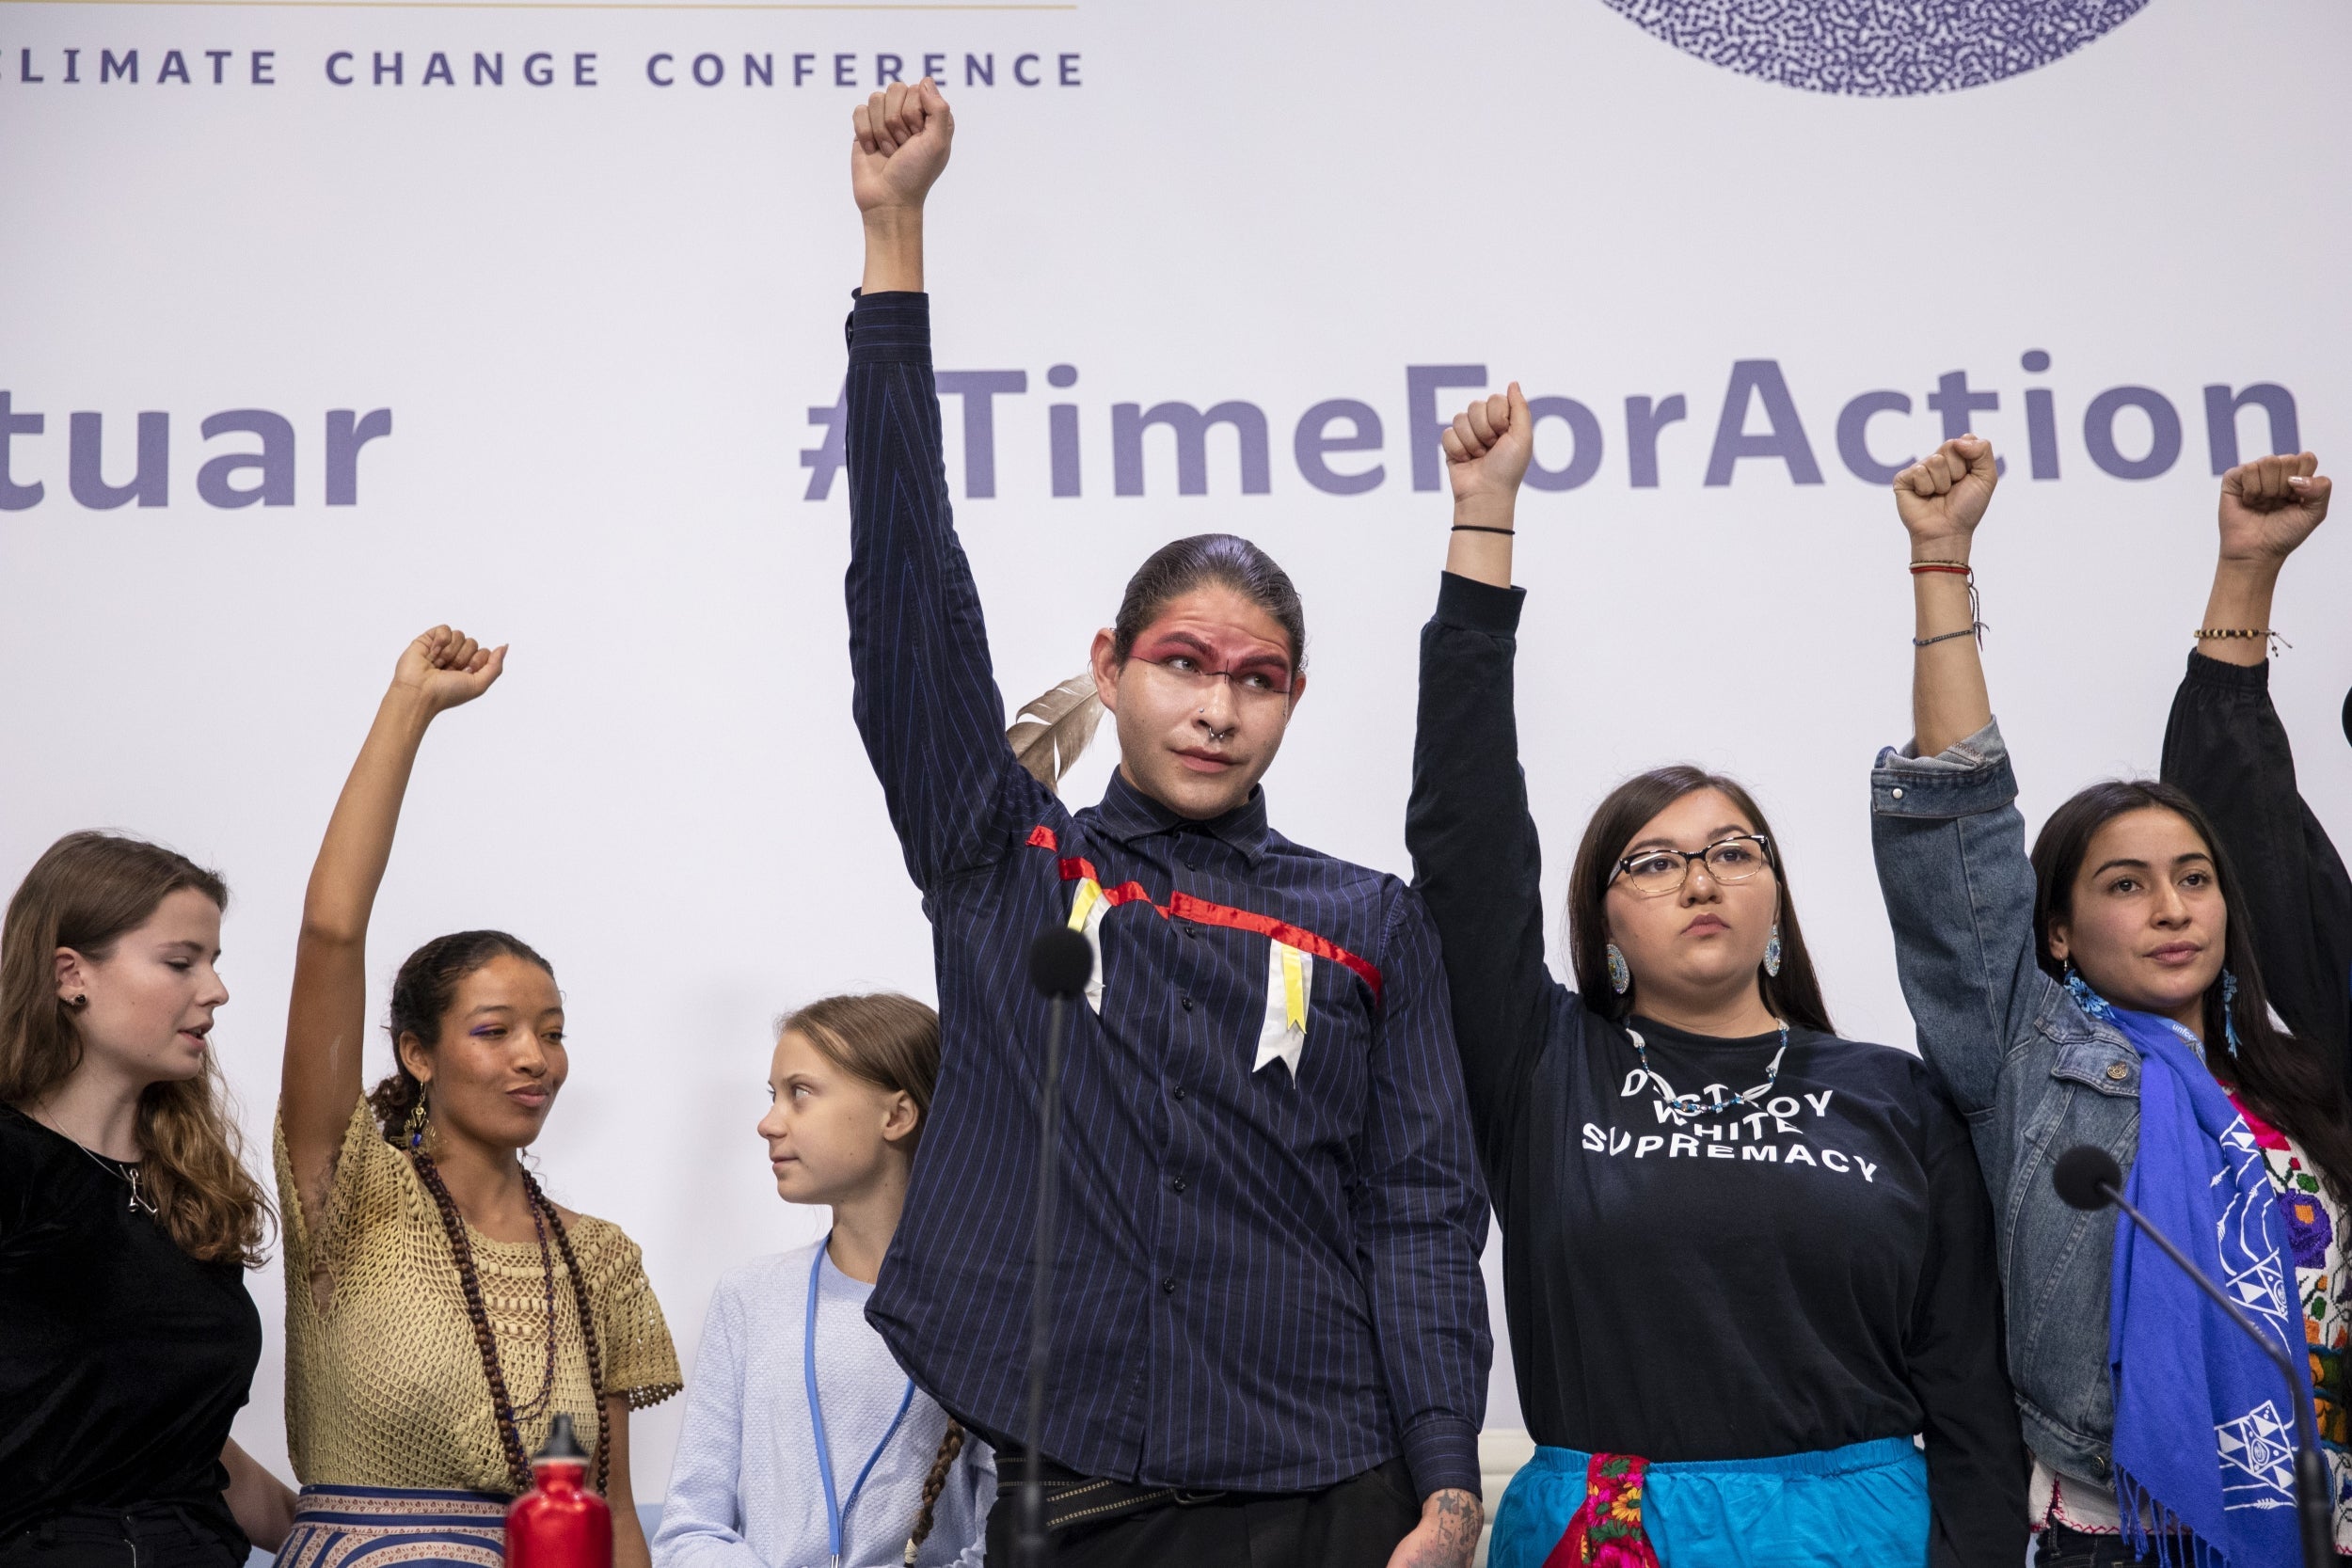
[988,1455,1421,1568]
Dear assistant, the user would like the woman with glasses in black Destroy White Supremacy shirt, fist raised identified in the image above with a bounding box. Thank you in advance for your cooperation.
[1406,386,2026,1568]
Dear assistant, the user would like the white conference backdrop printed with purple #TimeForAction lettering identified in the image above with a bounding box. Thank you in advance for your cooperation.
[0,0,2352,1497]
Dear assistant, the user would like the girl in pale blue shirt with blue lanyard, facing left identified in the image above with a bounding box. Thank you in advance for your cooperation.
[654,992,997,1568]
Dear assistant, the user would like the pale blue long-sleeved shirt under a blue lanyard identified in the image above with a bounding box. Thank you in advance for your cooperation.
[654,1242,997,1568]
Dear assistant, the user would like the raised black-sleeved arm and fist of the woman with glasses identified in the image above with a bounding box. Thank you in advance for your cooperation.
[1405,386,1562,1209]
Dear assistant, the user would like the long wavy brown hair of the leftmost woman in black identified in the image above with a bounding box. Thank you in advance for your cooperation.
[0,832,271,1267]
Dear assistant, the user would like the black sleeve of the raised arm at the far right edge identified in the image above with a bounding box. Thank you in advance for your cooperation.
[2164,654,2352,1074]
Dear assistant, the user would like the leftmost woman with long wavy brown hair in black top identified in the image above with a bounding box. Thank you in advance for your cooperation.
[0,832,294,1568]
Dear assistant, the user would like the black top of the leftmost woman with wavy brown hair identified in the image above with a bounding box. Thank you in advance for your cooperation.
[0,1105,262,1561]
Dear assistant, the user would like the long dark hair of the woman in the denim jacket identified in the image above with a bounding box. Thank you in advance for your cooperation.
[2035,778,2352,1204]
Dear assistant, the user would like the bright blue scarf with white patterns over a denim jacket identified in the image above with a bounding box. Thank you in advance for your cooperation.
[2087,997,2308,1568]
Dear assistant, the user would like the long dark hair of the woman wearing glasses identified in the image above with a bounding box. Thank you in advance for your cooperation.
[1569,762,1837,1035]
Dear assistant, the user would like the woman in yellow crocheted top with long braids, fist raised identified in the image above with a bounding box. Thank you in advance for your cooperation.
[278,627,677,1568]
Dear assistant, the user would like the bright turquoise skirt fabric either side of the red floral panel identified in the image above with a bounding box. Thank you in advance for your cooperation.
[1486,1436,1929,1568]
